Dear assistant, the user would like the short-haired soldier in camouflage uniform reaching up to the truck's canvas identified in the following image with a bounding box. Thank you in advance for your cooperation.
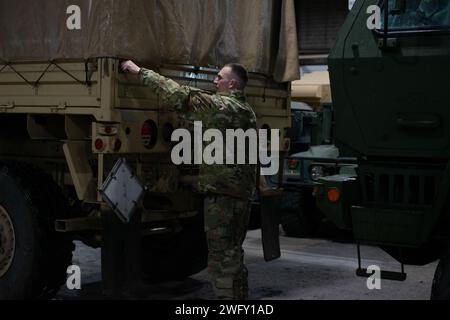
[122,61,256,299]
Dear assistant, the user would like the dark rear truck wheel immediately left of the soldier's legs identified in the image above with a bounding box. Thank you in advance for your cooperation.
[142,213,208,282]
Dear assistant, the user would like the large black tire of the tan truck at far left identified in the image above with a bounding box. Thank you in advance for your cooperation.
[0,162,74,300]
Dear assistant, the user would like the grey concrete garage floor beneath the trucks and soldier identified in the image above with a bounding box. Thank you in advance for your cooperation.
[56,230,437,300]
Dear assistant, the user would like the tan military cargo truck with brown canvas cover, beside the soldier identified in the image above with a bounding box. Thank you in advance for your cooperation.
[0,0,298,299]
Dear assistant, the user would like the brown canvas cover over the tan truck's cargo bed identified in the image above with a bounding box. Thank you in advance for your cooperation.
[0,0,299,82]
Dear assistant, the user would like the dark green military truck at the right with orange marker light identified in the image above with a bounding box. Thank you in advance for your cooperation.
[316,0,450,299]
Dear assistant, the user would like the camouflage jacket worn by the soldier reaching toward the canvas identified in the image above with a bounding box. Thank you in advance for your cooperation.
[139,68,256,198]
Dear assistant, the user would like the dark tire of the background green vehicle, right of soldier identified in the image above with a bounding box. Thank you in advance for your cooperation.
[281,190,320,238]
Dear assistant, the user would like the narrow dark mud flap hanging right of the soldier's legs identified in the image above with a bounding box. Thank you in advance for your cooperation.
[260,190,281,261]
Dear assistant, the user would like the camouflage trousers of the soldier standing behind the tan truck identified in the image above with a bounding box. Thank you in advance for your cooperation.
[204,195,250,299]
